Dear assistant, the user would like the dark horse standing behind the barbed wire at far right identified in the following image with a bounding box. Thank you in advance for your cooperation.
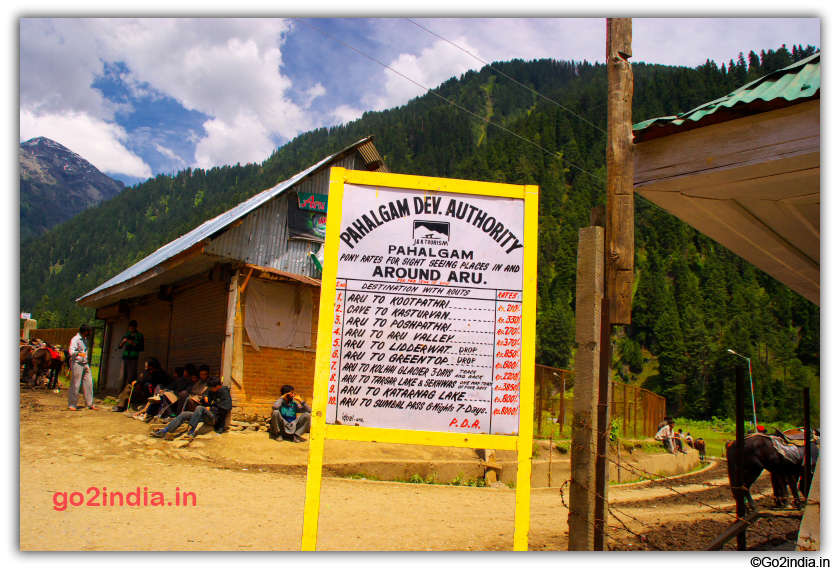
[726,432,819,511]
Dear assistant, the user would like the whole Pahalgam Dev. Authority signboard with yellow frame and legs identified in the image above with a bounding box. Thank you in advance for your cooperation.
[304,168,539,550]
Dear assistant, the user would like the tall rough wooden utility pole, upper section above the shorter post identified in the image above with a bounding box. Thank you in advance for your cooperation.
[605,18,634,325]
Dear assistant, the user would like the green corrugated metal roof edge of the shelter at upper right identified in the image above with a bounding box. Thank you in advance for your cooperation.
[633,53,820,142]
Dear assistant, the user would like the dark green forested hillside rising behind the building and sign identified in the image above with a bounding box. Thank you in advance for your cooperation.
[20,46,820,421]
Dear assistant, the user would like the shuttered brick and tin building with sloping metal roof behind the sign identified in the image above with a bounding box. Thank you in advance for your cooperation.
[78,137,388,416]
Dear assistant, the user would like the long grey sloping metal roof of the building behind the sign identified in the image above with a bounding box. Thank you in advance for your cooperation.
[76,137,378,303]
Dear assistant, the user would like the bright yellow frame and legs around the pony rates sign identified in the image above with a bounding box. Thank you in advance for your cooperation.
[301,167,539,550]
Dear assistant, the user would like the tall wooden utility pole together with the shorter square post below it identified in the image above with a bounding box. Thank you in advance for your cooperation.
[569,18,633,550]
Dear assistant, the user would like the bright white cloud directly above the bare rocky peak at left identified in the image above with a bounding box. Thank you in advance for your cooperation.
[20,109,152,178]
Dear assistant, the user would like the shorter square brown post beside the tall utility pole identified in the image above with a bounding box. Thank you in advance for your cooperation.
[569,226,604,550]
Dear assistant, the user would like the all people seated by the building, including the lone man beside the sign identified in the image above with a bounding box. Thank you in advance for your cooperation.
[112,357,312,443]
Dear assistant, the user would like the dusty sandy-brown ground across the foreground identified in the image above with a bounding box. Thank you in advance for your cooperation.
[20,389,798,550]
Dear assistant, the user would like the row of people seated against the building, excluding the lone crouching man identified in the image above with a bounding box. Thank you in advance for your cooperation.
[112,357,233,440]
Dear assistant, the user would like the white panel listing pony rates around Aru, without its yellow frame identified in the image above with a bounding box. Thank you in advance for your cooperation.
[327,184,525,435]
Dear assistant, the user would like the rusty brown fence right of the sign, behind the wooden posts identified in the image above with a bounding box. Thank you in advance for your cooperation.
[534,364,665,439]
